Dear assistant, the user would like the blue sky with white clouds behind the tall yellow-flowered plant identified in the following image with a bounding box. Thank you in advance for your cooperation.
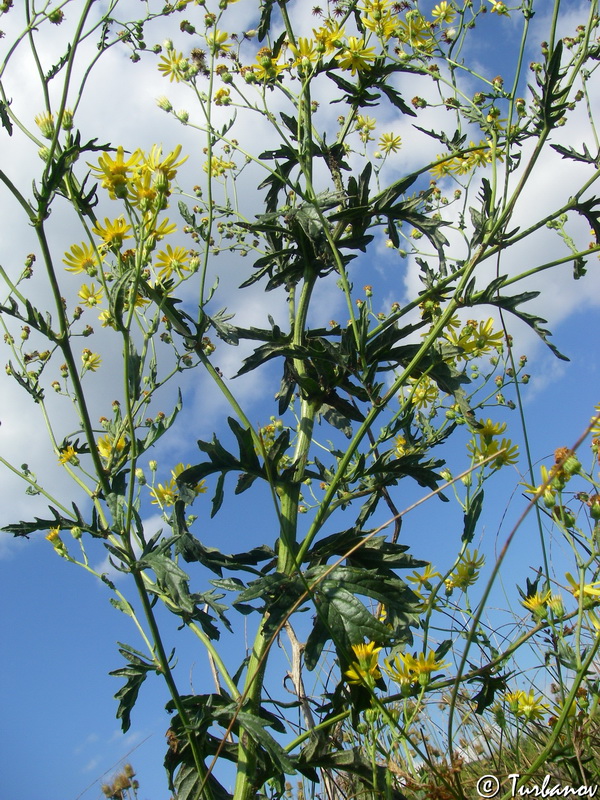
[0,0,600,800]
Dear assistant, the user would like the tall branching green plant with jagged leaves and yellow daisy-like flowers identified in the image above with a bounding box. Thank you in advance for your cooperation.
[0,0,600,800]
